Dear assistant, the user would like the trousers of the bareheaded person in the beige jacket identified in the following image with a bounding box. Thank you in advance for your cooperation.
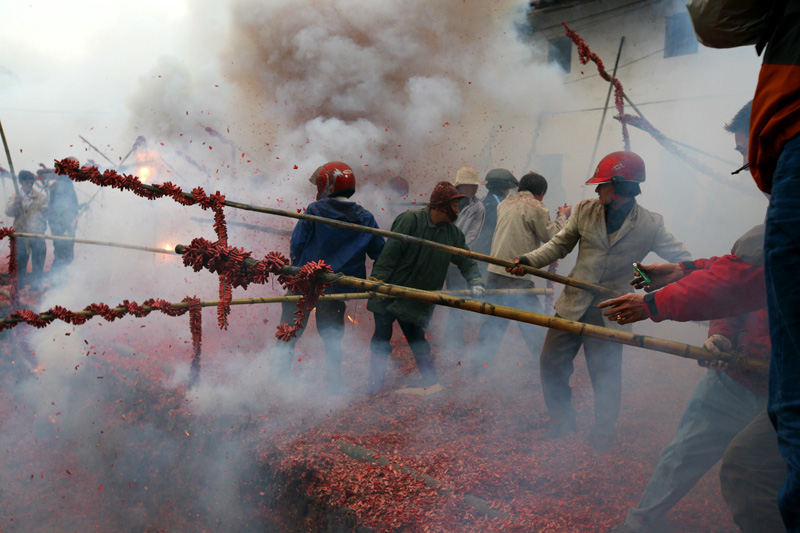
[472,272,545,369]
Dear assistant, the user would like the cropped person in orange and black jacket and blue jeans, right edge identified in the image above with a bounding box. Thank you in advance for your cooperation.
[689,0,800,531]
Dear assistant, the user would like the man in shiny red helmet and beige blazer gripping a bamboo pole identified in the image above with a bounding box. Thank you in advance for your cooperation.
[509,152,691,450]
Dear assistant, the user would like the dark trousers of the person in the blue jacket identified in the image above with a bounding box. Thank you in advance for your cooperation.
[277,294,347,381]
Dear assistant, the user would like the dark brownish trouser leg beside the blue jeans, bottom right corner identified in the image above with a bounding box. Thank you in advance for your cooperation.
[719,410,786,533]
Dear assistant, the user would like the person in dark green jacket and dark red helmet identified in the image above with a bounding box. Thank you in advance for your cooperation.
[367,181,484,395]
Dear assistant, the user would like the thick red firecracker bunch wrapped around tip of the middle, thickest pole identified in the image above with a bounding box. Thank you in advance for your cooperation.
[182,238,333,341]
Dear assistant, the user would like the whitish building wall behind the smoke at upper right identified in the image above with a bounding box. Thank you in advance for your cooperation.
[476,0,766,264]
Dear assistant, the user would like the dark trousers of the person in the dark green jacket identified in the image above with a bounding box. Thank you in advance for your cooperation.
[369,313,439,391]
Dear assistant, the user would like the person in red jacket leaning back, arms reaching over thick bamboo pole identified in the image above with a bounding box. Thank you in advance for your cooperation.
[600,104,783,533]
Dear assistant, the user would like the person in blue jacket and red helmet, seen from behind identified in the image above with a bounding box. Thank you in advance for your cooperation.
[278,161,384,392]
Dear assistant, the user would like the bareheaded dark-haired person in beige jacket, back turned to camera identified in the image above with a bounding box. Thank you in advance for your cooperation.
[472,172,572,376]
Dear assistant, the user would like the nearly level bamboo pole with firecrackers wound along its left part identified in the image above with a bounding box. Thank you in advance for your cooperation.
[0,288,553,324]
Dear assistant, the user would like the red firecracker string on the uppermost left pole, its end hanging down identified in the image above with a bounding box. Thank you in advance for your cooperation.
[54,159,232,329]
